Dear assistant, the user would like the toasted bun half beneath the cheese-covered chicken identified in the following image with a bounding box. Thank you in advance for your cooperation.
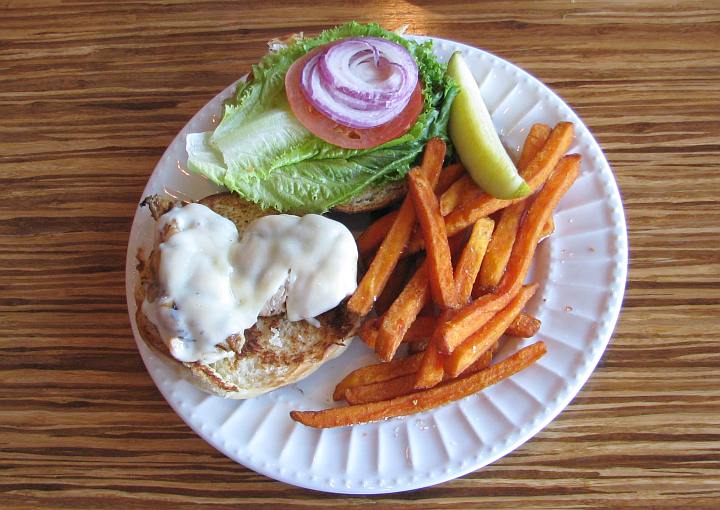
[135,193,357,399]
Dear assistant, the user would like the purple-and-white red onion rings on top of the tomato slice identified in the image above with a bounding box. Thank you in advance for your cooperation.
[300,37,418,129]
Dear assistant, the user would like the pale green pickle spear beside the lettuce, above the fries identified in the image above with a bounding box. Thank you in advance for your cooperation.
[447,52,530,199]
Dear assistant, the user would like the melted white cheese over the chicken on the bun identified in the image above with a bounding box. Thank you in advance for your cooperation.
[143,204,358,363]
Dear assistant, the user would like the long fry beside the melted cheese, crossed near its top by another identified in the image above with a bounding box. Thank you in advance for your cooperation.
[347,138,446,317]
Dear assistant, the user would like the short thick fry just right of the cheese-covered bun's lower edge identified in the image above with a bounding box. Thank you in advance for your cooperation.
[375,261,430,361]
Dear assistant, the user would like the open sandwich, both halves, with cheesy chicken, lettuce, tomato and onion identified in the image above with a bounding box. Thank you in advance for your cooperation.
[135,22,457,398]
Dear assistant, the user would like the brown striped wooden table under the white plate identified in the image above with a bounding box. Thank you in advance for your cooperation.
[0,1,720,509]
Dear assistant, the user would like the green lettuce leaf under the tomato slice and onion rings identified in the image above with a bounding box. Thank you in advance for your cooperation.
[186,22,457,213]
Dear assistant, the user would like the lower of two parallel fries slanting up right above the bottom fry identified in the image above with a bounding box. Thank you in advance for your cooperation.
[445,284,538,377]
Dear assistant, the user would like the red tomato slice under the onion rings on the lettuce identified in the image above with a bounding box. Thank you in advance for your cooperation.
[285,47,424,149]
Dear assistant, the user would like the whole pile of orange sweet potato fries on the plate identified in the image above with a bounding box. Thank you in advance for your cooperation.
[290,122,580,428]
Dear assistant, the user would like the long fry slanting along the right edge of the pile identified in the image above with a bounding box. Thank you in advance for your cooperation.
[497,154,580,294]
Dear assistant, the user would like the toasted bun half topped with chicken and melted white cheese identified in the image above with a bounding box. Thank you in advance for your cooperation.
[135,193,357,398]
